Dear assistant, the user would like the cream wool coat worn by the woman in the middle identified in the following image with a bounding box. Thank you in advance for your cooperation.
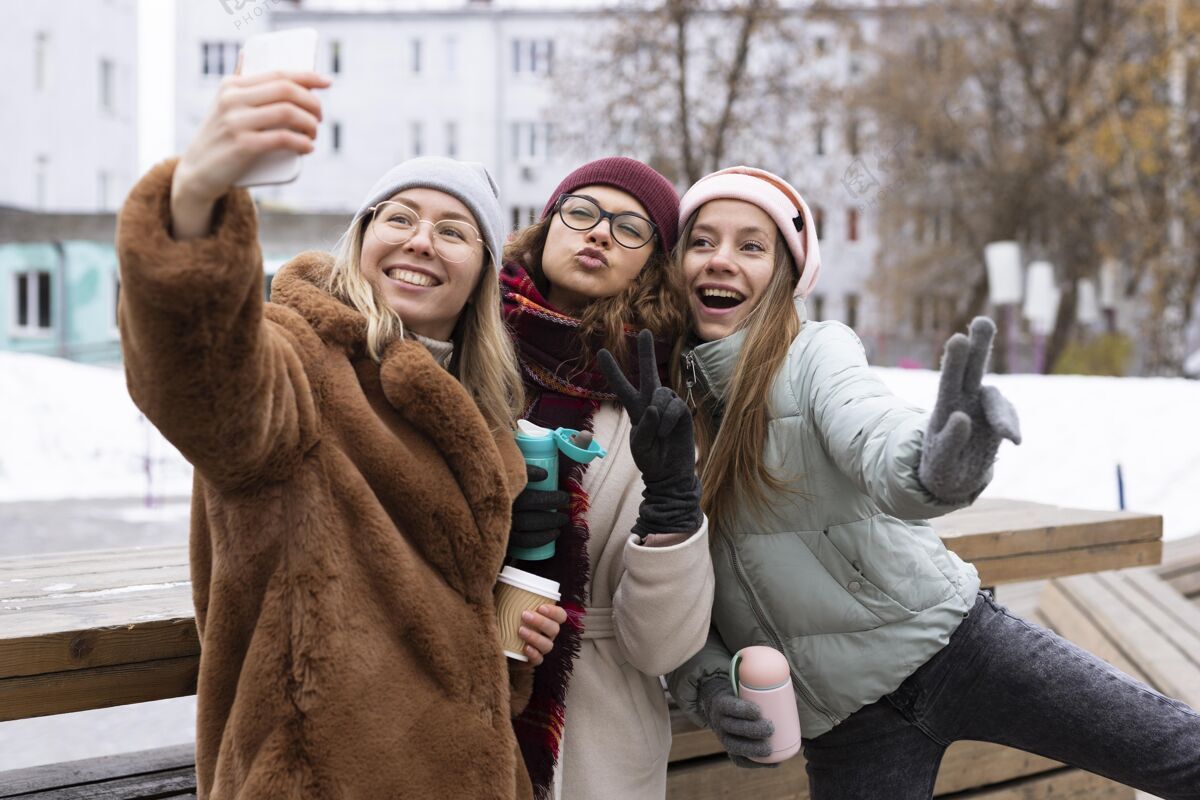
[554,403,713,800]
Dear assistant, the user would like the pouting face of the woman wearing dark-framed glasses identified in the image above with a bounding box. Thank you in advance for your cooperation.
[541,186,656,314]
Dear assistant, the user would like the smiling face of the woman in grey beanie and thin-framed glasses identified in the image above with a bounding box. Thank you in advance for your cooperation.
[360,188,486,342]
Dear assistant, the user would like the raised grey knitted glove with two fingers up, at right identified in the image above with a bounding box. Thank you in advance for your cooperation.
[917,317,1021,503]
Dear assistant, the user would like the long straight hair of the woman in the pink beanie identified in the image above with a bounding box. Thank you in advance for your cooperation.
[671,210,800,534]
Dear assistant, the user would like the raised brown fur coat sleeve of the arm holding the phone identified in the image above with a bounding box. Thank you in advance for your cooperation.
[116,161,320,488]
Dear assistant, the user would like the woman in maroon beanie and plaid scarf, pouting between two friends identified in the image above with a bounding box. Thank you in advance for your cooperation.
[500,157,713,800]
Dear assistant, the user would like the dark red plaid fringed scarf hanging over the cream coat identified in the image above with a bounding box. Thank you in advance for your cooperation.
[500,261,667,800]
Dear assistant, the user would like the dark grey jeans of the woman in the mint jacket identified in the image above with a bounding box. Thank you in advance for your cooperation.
[804,594,1200,800]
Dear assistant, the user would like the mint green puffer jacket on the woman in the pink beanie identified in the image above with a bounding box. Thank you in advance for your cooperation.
[668,301,979,739]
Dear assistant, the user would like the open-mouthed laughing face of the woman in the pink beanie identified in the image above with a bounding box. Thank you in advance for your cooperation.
[683,200,778,342]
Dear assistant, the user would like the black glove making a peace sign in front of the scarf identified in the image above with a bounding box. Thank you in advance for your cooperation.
[598,331,704,537]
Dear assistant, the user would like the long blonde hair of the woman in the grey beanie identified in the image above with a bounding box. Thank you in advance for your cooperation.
[326,216,524,433]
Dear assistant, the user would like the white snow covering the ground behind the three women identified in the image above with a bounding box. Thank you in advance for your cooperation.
[0,353,1200,539]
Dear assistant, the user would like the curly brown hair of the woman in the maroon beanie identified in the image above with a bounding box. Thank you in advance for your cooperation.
[504,205,688,367]
